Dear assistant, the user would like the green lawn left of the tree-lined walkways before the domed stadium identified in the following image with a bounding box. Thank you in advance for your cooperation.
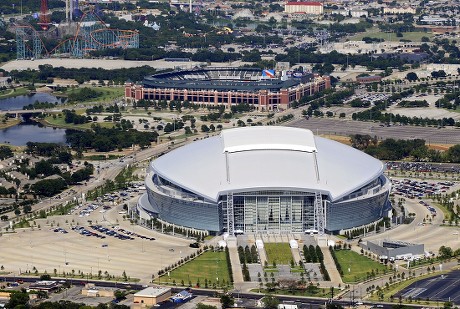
[161,251,230,287]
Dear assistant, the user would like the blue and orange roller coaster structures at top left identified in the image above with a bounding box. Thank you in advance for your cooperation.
[15,0,139,60]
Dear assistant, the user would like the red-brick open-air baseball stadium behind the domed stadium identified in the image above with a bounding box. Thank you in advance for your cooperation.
[125,68,331,111]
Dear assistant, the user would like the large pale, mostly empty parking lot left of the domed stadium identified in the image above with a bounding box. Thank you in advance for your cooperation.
[0,200,196,283]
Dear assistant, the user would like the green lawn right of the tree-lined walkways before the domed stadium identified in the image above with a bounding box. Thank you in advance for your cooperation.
[335,250,387,282]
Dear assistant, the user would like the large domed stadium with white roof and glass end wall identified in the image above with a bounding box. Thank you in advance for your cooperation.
[137,126,391,234]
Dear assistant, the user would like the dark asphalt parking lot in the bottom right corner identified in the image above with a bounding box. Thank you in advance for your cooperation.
[396,270,460,304]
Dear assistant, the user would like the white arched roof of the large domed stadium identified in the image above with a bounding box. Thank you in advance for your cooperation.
[152,126,384,201]
